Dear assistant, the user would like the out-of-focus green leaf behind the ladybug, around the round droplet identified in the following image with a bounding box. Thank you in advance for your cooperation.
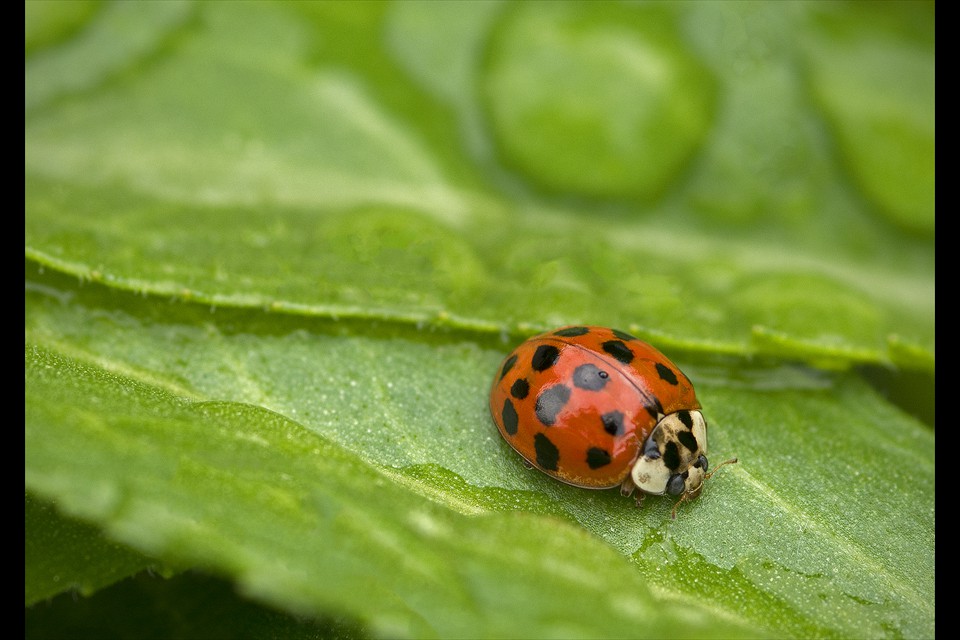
[25,3,935,370]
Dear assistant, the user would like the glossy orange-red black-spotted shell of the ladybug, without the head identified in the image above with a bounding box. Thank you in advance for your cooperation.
[490,326,700,489]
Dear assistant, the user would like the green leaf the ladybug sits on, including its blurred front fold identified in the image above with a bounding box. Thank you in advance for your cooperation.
[26,268,933,637]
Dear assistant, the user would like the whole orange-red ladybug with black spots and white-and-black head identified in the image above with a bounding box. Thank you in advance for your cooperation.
[490,326,737,518]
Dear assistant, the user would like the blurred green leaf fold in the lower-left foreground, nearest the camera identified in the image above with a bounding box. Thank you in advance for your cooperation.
[26,330,752,637]
